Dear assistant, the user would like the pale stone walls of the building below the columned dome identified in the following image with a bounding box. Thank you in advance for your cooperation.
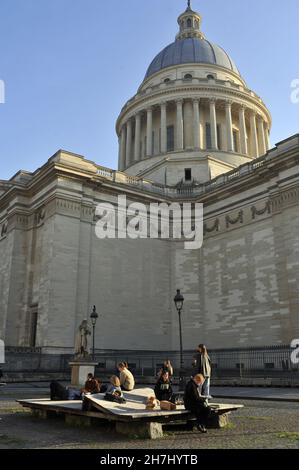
[0,136,299,353]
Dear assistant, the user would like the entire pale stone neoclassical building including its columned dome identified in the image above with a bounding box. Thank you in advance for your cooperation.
[0,2,299,360]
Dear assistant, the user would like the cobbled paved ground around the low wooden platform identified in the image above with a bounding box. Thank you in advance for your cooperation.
[0,384,299,450]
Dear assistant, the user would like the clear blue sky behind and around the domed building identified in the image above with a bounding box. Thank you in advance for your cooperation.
[0,0,299,179]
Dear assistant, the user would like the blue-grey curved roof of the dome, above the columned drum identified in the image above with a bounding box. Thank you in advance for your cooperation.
[145,37,240,79]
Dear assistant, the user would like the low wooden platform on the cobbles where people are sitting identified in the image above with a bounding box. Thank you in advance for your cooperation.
[18,389,243,439]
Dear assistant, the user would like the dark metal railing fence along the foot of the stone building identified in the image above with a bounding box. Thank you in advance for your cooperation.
[1,346,299,381]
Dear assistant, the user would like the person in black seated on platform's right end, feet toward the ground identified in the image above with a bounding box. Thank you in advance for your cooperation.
[184,374,210,433]
